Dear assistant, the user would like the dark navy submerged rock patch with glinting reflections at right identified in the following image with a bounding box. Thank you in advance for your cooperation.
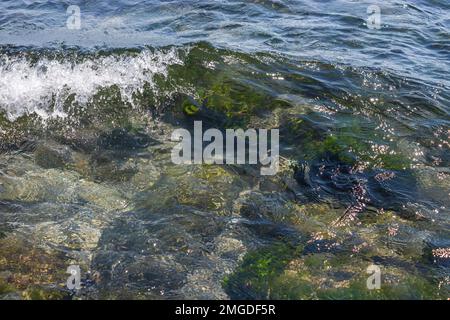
[294,154,425,219]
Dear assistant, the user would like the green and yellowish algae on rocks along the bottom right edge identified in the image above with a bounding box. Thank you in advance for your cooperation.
[223,240,446,300]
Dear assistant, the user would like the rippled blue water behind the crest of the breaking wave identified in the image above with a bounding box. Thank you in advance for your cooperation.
[0,0,450,86]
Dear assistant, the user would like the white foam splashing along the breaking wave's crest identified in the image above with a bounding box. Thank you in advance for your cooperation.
[0,49,182,120]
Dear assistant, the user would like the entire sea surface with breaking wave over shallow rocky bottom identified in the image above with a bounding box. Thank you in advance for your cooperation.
[0,0,450,299]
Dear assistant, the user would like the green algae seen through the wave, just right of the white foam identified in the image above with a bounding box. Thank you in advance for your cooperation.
[165,44,290,127]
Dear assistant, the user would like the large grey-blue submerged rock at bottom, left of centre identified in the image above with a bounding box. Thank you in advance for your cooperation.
[92,208,220,298]
